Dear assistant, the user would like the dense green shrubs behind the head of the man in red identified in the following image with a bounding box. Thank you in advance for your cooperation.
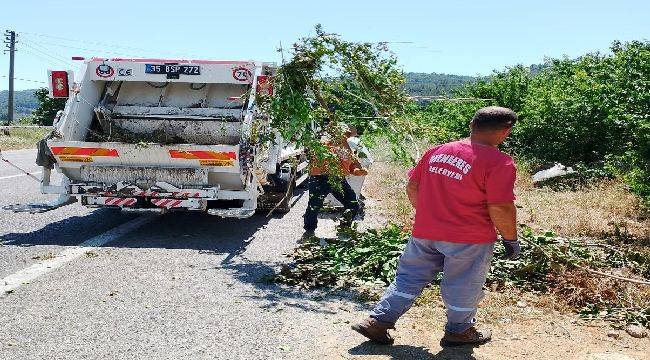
[410,41,650,205]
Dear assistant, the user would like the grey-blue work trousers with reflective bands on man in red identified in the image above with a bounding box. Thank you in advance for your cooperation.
[370,237,494,333]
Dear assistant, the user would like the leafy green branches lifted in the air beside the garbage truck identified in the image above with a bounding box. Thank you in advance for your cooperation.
[258,25,409,168]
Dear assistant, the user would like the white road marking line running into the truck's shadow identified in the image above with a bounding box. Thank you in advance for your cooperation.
[0,214,156,297]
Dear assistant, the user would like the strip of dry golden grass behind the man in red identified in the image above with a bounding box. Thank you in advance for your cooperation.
[364,155,650,243]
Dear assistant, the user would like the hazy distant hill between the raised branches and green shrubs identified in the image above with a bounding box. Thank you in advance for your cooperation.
[404,73,476,96]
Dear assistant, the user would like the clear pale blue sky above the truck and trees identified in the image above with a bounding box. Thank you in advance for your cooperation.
[0,0,650,90]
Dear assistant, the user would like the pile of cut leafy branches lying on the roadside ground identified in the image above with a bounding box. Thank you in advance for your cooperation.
[276,224,650,326]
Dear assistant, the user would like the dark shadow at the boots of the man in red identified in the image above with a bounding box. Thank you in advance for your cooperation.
[348,341,476,360]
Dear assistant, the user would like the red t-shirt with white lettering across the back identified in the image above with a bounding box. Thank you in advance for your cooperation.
[409,140,516,244]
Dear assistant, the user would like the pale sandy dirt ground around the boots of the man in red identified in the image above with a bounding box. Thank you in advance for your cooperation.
[323,293,650,360]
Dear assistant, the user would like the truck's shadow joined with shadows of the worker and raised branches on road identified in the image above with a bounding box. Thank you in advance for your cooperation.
[0,187,363,314]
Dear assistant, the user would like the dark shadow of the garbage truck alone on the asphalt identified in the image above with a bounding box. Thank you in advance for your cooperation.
[0,191,299,258]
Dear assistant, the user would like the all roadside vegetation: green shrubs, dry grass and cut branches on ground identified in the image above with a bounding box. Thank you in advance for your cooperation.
[278,31,650,327]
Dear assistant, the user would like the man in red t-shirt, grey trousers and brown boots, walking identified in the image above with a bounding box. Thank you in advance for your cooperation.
[352,107,520,346]
